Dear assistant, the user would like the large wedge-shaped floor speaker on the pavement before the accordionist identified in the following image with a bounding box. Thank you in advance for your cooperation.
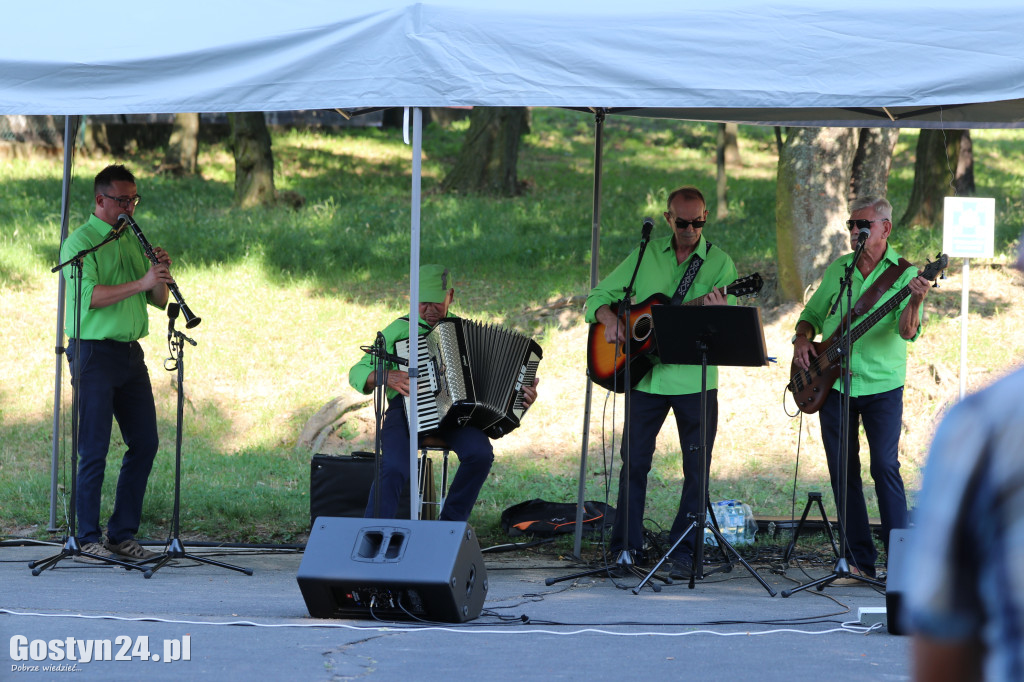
[298,516,487,623]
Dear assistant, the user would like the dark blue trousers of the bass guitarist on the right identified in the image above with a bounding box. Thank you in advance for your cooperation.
[818,386,907,576]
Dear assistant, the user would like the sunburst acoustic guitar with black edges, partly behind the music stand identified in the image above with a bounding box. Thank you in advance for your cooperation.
[587,272,764,393]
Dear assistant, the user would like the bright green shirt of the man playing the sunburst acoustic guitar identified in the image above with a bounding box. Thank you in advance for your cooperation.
[586,236,736,395]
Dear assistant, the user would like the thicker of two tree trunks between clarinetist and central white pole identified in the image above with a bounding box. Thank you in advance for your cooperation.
[227,112,276,208]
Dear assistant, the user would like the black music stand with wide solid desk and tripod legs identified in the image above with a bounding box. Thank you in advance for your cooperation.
[633,305,775,597]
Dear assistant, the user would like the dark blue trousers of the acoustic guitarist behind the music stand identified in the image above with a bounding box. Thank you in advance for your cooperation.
[610,389,718,560]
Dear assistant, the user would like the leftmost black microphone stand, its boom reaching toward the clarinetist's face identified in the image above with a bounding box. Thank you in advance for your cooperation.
[29,221,142,576]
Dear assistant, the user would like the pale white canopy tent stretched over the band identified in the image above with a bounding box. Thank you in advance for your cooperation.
[0,0,1024,553]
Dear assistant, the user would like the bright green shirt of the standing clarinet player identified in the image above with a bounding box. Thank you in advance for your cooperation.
[60,215,158,341]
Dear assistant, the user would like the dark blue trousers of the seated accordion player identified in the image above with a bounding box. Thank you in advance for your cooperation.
[364,395,495,521]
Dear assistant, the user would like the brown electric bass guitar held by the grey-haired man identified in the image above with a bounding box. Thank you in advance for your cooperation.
[786,253,949,415]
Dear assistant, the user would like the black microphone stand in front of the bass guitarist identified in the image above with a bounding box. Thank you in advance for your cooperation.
[779,229,886,597]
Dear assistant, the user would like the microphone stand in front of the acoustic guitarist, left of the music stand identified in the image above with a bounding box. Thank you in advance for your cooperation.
[544,218,672,592]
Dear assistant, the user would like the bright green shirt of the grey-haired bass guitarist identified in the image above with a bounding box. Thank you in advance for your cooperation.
[800,246,921,397]
